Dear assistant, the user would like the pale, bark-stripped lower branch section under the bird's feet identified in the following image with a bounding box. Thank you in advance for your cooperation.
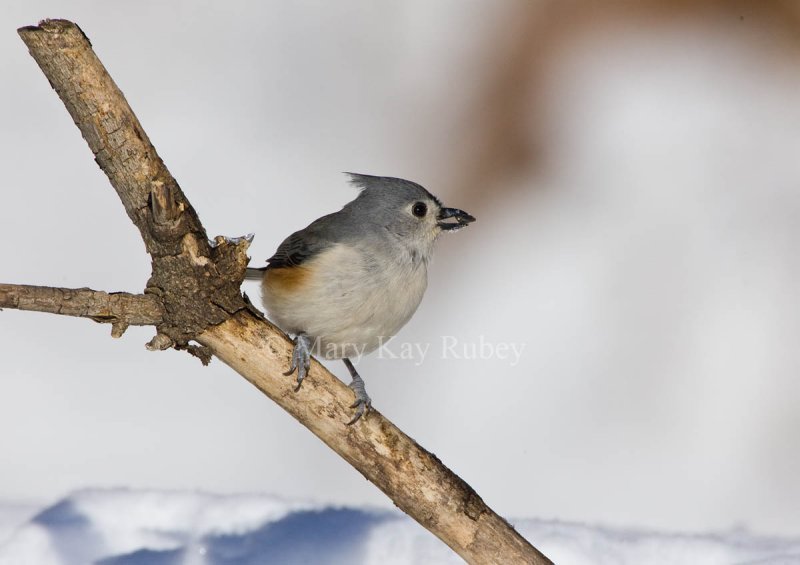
[198,312,550,565]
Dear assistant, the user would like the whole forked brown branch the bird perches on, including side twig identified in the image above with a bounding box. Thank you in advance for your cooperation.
[9,20,550,564]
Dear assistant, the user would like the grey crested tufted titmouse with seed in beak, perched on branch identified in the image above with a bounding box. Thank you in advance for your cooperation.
[247,173,475,424]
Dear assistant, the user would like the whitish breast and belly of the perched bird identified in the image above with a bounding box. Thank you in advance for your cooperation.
[263,244,428,359]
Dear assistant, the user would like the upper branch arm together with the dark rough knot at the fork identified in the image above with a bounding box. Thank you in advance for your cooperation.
[19,20,249,348]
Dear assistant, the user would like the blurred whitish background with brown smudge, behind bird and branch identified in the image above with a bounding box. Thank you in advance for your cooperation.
[0,0,800,563]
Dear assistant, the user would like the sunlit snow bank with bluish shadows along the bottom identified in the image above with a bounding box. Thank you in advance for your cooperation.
[0,489,800,565]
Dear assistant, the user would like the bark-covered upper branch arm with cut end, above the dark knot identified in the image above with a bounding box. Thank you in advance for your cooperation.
[18,20,208,256]
